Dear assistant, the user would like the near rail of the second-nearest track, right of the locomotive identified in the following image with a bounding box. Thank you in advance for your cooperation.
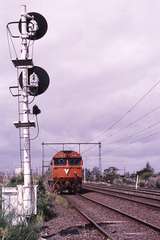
[83,186,160,209]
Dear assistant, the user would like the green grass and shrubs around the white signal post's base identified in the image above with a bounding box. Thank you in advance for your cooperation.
[0,177,56,240]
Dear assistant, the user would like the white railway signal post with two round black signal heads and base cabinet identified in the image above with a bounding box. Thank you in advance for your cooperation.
[2,5,49,224]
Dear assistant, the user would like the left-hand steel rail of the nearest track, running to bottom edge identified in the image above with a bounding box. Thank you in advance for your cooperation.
[67,195,114,240]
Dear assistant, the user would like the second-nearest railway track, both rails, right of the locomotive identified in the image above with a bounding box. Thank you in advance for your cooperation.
[83,185,160,209]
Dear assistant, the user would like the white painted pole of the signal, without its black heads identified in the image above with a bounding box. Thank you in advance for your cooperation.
[21,5,32,216]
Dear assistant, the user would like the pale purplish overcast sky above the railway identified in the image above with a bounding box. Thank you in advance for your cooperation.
[0,0,160,172]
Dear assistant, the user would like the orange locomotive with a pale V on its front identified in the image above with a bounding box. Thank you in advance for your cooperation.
[49,151,83,192]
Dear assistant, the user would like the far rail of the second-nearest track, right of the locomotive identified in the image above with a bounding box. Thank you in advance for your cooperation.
[83,184,160,201]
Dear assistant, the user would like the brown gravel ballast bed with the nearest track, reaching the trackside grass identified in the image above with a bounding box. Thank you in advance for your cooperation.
[41,192,160,240]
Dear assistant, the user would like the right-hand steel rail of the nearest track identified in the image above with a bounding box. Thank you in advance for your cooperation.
[80,194,160,232]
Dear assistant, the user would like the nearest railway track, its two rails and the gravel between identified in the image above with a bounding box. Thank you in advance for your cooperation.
[67,195,160,240]
